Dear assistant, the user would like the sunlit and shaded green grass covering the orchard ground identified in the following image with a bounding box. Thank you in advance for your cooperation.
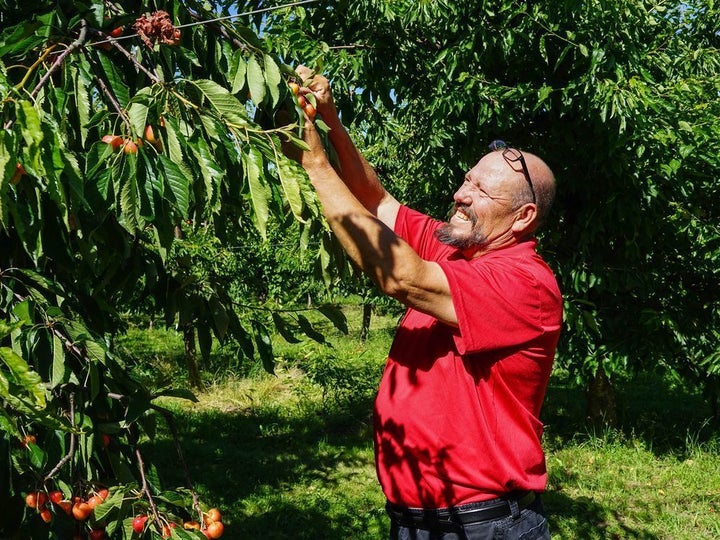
[115,311,720,540]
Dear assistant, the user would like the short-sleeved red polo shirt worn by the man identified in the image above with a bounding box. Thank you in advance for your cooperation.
[375,206,562,508]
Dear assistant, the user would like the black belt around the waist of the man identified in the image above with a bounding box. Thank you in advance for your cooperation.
[385,491,536,532]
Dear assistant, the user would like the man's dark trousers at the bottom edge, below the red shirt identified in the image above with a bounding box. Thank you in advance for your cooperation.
[388,495,550,540]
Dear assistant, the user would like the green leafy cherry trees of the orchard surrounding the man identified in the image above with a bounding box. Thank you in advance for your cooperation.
[0,0,720,539]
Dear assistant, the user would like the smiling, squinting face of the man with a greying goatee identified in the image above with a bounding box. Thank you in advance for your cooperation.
[437,152,518,252]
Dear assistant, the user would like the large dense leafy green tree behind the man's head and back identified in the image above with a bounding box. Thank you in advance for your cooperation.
[267,0,720,421]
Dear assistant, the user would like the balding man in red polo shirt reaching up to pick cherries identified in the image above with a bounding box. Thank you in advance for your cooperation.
[286,66,562,540]
